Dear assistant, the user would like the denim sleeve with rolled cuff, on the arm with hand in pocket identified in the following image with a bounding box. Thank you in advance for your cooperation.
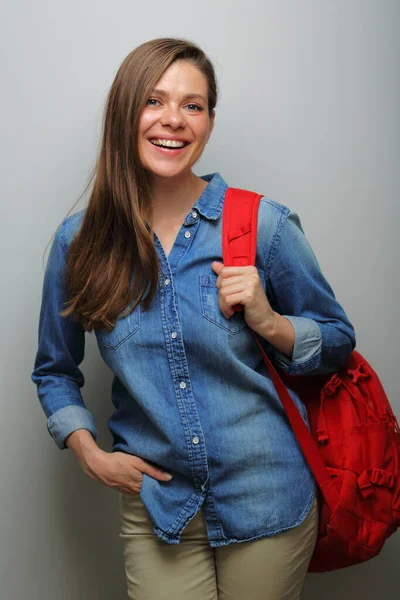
[31,221,97,449]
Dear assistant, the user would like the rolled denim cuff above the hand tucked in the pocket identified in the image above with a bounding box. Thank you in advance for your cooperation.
[47,404,97,450]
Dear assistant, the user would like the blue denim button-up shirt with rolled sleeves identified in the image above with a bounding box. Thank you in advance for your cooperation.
[31,173,355,547]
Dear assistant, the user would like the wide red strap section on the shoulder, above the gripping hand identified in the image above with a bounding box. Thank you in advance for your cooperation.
[222,188,262,267]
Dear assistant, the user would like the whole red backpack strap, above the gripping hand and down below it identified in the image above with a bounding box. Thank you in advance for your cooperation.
[222,188,338,510]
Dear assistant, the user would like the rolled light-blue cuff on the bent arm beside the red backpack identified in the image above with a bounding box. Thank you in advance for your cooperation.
[274,315,322,375]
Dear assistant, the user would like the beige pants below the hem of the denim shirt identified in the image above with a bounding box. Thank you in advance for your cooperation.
[119,493,318,600]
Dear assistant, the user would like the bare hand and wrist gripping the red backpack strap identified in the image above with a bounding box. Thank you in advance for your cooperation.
[211,261,276,335]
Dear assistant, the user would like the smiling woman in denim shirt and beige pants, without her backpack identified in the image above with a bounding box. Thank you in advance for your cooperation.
[32,38,355,600]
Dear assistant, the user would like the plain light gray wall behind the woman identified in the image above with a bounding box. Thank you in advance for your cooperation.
[0,0,400,600]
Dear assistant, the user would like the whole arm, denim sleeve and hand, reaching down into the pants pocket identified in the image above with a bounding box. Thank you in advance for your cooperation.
[31,221,172,494]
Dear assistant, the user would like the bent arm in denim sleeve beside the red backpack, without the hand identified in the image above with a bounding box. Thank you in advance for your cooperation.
[263,212,355,375]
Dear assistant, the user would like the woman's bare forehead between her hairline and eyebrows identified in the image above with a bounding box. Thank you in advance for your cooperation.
[155,60,207,94]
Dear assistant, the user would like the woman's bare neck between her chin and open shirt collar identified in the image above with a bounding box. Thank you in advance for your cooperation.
[151,171,207,217]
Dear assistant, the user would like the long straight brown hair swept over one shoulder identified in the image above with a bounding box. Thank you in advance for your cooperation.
[56,38,218,331]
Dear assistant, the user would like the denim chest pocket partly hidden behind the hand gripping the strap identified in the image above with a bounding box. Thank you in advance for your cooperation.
[200,275,247,334]
